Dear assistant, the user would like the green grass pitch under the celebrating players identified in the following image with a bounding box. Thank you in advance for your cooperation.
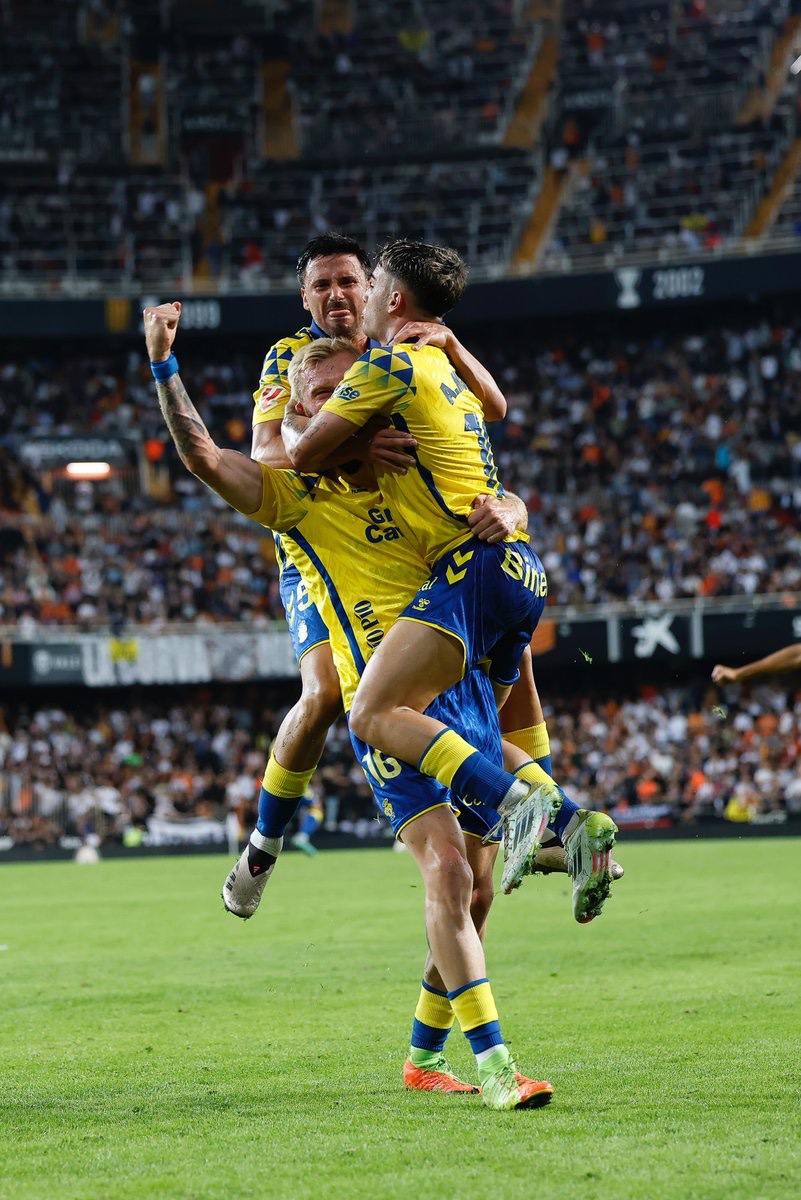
[0,839,801,1200]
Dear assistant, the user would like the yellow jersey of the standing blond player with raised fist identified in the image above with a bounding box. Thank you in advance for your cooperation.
[239,464,428,712]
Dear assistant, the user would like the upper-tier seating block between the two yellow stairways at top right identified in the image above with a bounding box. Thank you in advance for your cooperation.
[543,0,795,269]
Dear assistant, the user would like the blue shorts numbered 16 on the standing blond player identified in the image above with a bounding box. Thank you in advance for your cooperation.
[350,670,504,841]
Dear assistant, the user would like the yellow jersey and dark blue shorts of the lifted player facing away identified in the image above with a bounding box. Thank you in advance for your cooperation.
[323,346,548,683]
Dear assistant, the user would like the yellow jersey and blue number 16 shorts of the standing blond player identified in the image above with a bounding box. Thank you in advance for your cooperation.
[236,464,502,835]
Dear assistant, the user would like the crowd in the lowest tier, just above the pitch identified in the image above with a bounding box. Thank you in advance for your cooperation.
[0,678,801,846]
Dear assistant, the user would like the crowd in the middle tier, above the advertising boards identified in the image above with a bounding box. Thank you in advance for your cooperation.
[0,304,801,629]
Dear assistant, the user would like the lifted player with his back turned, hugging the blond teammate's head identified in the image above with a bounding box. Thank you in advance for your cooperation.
[283,241,616,902]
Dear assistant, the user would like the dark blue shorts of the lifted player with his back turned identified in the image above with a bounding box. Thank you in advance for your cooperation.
[398,538,548,686]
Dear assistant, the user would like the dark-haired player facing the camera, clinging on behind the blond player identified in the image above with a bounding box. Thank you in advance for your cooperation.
[236,233,506,916]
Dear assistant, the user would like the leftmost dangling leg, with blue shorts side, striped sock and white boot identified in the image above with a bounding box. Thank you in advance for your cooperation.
[222,564,342,918]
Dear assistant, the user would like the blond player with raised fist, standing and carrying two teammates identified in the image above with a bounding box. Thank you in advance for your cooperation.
[145,306,553,1109]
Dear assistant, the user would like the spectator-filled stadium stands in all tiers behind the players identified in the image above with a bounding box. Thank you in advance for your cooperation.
[0,0,801,846]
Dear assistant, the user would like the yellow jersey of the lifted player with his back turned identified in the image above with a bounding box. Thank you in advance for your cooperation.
[323,346,525,565]
